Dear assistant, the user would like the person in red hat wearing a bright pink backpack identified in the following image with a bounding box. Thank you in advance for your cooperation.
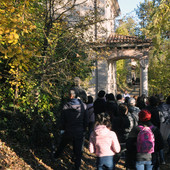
[126,110,164,170]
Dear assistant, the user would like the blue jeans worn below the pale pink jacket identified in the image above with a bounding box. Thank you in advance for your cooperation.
[97,156,114,170]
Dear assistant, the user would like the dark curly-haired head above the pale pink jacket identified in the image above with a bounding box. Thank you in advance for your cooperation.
[95,112,111,129]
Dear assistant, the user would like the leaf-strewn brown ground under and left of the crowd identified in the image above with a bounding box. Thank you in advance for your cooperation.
[0,139,170,170]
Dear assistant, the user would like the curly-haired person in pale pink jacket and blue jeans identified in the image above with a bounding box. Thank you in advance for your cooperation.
[89,113,120,170]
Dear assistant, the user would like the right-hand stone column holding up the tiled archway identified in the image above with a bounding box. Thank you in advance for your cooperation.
[140,57,148,96]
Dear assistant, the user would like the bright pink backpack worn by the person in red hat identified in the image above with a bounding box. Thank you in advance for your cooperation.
[137,125,155,153]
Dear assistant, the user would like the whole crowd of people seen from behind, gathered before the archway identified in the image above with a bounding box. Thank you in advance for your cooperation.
[54,78,170,170]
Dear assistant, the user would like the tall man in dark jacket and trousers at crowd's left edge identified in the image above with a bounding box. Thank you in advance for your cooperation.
[54,88,88,170]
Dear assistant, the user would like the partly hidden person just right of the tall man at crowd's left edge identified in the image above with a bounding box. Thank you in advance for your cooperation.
[86,96,95,138]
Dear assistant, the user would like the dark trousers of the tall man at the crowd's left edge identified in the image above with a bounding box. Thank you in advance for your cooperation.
[55,132,84,170]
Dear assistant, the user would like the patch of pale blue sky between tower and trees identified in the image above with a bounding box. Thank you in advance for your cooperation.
[118,0,144,17]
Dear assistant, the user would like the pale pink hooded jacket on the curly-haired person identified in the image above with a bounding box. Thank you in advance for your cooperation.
[89,125,120,157]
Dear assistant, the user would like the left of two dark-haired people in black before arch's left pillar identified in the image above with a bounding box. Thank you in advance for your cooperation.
[93,90,106,116]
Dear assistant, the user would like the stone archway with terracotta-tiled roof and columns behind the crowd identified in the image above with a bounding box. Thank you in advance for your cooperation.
[92,34,152,96]
